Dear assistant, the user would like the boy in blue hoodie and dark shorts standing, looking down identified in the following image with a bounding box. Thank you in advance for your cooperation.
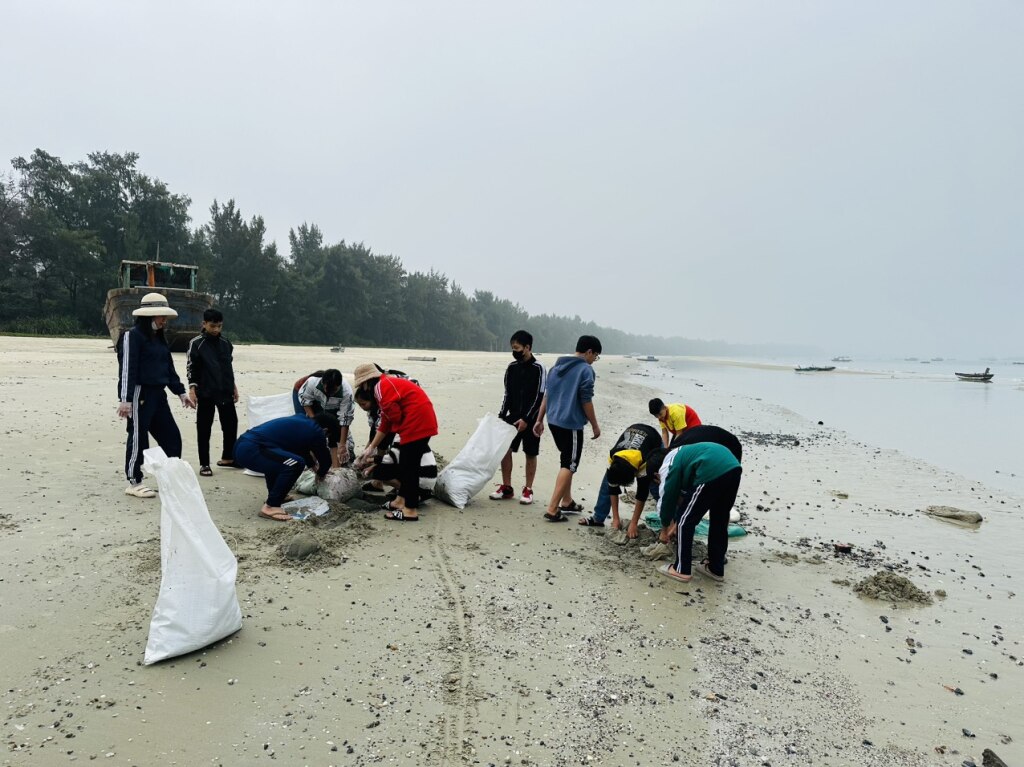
[534,336,601,522]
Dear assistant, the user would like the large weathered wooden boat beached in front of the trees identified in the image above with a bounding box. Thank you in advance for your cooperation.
[103,261,213,351]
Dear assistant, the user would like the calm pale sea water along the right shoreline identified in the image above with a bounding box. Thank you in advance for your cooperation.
[643,358,1024,496]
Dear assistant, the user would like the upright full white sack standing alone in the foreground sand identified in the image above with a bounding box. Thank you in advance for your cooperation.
[142,448,242,666]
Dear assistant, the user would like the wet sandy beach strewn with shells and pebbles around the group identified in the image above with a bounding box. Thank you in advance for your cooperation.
[0,337,1024,767]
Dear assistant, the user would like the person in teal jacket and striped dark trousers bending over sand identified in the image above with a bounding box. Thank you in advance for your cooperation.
[647,442,743,583]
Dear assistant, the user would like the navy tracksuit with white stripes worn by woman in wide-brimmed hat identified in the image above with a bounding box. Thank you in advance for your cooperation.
[118,325,185,484]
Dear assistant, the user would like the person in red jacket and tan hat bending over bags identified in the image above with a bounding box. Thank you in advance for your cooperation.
[352,365,437,522]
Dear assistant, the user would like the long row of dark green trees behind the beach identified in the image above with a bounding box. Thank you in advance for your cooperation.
[0,150,794,354]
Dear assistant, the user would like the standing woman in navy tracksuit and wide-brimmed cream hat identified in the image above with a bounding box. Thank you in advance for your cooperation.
[118,293,196,498]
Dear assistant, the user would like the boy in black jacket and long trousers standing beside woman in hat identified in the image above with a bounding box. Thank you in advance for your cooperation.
[185,309,239,477]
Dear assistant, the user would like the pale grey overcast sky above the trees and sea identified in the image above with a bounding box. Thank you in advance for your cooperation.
[0,0,1024,356]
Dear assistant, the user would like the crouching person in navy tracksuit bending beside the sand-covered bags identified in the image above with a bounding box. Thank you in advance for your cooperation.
[234,413,337,522]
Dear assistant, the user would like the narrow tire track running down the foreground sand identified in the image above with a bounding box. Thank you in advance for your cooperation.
[427,532,473,765]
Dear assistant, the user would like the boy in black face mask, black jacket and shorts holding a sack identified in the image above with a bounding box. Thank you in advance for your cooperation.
[490,330,547,504]
